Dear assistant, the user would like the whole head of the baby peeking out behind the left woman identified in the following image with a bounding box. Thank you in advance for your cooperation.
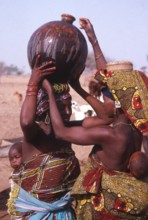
[8,142,22,170]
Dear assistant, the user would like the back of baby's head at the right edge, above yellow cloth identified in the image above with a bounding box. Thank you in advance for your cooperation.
[129,151,148,179]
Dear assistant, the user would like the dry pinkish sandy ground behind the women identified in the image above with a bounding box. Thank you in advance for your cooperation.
[0,75,92,220]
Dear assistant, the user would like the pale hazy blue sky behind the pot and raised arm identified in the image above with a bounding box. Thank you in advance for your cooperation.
[0,0,148,72]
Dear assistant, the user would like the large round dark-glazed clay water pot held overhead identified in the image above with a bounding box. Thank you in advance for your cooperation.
[27,14,88,82]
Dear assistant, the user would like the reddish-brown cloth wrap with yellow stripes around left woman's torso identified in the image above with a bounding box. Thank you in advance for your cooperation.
[7,151,80,216]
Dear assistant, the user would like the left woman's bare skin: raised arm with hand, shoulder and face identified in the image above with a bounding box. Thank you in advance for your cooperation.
[20,56,74,161]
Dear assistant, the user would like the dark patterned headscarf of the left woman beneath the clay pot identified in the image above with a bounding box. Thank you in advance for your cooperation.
[36,83,71,117]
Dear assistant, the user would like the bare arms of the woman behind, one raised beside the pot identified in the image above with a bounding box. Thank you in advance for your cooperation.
[70,18,115,127]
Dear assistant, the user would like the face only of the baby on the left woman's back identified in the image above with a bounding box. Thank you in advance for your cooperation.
[9,149,22,170]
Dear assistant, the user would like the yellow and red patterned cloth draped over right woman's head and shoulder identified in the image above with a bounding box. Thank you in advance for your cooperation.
[95,70,148,135]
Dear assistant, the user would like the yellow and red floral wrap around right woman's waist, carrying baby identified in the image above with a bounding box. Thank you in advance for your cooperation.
[71,158,148,220]
